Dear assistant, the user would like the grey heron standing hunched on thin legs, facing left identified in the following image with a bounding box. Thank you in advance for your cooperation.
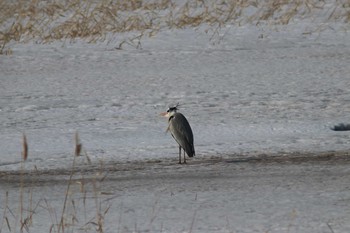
[161,104,195,164]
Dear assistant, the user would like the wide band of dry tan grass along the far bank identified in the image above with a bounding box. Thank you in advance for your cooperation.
[0,0,350,54]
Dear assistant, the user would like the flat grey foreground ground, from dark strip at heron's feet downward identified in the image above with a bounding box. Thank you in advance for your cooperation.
[0,152,350,232]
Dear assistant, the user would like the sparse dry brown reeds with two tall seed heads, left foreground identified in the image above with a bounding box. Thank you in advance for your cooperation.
[0,133,110,233]
